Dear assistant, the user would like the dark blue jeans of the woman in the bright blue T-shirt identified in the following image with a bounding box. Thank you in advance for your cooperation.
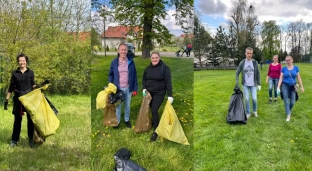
[281,83,296,116]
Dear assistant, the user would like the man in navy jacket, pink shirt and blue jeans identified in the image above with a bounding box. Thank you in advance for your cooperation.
[108,43,138,128]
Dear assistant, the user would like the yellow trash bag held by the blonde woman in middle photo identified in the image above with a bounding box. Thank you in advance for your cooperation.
[156,101,190,145]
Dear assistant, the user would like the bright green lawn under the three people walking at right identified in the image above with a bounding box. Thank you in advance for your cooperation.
[194,64,312,171]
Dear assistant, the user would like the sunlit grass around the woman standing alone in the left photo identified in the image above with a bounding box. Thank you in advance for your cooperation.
[0,95,91,171]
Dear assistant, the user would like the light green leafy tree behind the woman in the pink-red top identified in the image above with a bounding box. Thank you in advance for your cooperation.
[261,20,281,59]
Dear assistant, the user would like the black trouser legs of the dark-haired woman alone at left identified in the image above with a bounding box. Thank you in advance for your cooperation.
[12,112,34,141]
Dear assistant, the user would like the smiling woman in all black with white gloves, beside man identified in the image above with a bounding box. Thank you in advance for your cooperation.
[142,52,173,141]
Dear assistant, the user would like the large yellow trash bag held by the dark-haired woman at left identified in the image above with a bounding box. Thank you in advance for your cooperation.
[18,85,60,137]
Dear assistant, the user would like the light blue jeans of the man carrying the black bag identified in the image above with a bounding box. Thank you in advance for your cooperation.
[243,85,257,115]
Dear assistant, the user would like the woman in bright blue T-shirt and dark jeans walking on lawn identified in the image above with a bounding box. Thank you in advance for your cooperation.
[277,56,304,122]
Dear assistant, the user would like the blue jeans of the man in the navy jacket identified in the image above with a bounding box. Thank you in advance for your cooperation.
[116,88,131,123]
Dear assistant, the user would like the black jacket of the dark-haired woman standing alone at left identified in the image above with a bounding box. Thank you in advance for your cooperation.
[8,68,35,115]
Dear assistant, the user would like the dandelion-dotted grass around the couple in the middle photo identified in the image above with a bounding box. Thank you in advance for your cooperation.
[91,56,193,171]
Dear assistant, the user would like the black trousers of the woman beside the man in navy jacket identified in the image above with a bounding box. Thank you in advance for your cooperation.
[150,92,165,130]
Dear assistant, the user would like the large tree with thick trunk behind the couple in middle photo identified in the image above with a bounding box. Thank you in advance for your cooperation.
[110,0,194,58]
